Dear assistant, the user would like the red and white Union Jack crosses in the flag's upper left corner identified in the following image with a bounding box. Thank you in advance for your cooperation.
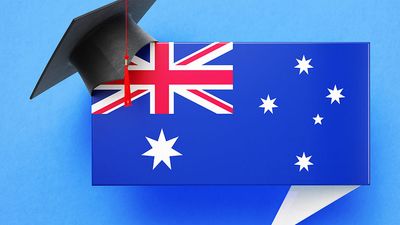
[92,42,233,114]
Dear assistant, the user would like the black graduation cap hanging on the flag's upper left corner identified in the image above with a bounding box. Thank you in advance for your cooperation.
[30,0,155,99]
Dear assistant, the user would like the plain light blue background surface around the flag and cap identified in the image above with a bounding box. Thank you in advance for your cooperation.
[0,0,400,224]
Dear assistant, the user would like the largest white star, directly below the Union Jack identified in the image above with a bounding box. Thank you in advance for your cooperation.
[142,130,182,170]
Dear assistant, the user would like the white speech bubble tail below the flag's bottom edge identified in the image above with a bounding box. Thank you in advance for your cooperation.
[272,186,359,225]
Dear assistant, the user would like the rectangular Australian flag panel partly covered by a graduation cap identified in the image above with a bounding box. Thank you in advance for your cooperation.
[92,42,369,185]
